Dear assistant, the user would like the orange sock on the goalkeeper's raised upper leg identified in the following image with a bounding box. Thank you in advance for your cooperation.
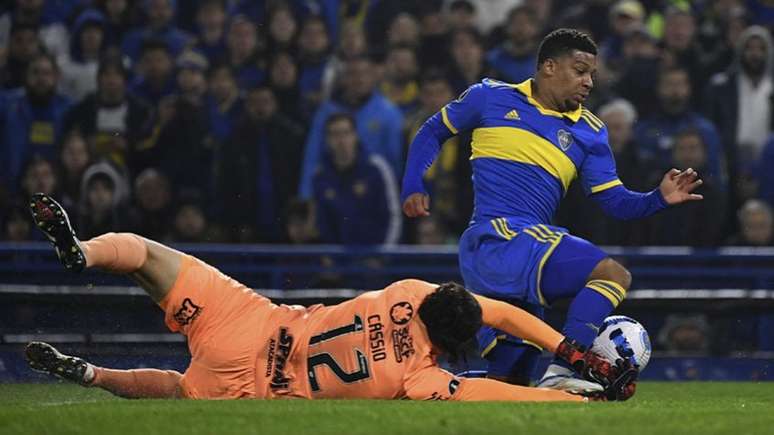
[81,233,148,273]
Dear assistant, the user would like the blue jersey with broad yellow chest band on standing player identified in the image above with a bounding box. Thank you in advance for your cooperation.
[440,79,621,225]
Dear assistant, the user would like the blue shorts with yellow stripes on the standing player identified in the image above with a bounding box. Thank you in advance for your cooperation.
[459,218,607,362]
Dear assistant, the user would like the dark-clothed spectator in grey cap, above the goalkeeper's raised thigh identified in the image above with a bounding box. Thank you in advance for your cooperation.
[148,51,216,195]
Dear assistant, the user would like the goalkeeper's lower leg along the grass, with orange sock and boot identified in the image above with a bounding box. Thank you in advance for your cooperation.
[25,341,182,399]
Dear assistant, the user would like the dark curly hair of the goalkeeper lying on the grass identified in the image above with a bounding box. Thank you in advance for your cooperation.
[419,282,482,361]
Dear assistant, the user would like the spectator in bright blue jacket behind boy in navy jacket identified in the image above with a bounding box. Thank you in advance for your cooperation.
[299,56,403,199]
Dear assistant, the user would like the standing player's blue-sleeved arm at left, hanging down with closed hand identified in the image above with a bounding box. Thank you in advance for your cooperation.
[401,84,486,217]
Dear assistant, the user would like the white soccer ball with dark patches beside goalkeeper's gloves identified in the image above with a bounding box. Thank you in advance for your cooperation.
[591,316,651,372]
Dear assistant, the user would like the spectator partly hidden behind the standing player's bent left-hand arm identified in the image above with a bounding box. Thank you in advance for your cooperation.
[406,73,473,234]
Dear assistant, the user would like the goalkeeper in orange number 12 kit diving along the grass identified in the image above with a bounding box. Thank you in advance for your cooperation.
[26,194,636,401]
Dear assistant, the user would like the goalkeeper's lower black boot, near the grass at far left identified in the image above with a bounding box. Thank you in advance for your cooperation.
[24,341,94,385]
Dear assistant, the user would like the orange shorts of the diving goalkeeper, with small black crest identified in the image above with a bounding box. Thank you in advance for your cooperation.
[159,255,277,399]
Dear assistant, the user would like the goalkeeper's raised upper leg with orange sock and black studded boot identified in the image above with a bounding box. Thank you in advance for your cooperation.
[30,193,183,302]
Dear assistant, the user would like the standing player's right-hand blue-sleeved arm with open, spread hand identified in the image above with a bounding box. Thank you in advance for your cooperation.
[581,128,702,220]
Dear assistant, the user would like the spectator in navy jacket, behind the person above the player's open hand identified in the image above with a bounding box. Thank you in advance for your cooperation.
[635,67,726,186]
